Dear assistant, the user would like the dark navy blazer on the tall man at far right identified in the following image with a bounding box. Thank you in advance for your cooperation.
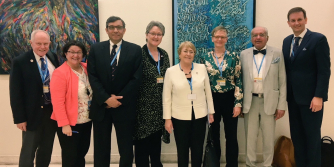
[283,30,331,105]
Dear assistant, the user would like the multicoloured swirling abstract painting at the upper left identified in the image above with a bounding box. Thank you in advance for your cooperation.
[0,0,99,74]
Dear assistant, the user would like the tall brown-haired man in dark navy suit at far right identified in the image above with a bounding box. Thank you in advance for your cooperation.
[283,7,330,167]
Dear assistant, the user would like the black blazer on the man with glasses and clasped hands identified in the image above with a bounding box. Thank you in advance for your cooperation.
[87,40,142,121]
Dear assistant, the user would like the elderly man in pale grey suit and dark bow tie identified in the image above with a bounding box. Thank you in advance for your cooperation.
[240,27,286,167]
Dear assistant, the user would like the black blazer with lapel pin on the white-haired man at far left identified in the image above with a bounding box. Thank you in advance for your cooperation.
[9,50,59,130]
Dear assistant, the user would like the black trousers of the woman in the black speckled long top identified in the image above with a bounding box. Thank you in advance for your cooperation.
[134,130,162,167]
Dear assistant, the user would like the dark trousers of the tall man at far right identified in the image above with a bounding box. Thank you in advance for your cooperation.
[288,93,323,167]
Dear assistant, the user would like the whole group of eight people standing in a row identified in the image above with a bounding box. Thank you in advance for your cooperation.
[10,7,330,167]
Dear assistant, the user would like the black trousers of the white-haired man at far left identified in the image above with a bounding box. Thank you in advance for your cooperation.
[19,105,57,167]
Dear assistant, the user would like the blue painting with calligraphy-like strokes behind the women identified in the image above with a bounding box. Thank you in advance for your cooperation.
[173,0,255,64]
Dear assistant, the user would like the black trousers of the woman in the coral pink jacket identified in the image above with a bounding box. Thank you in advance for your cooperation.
[57,121,92,167]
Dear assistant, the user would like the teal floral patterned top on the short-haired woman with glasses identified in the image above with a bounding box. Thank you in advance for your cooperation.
[200,51,243,107]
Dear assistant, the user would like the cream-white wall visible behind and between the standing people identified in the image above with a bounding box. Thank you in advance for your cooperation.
[0,0,334,164]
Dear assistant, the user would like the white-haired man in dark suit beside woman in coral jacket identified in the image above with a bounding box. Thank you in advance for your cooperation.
[9,30,59,167]
